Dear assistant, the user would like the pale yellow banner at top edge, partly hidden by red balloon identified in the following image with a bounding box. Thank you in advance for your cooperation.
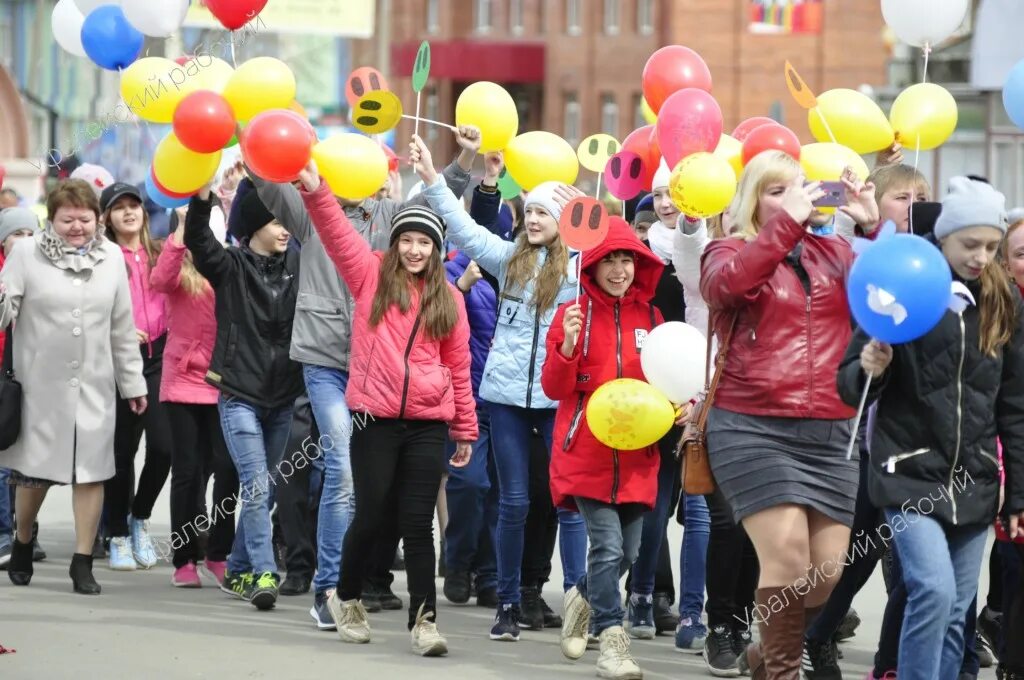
[184,0,376,38]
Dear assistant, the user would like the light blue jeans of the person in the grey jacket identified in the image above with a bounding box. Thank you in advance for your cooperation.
[302,364,355,593]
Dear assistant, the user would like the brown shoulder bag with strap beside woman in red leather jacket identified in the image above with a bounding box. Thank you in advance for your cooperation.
[676,314,736,496]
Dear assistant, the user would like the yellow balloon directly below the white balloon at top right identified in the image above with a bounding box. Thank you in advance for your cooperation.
[889,83,957,152]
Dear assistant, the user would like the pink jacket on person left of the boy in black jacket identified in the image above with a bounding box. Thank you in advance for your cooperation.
[150,238,219,403]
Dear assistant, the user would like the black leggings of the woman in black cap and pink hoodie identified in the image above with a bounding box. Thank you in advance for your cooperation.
[103,335,172,538]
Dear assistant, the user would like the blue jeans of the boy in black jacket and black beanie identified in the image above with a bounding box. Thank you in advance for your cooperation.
[217,394,292,575]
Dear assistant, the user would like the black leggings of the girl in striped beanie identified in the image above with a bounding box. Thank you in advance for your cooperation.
[338,418,447,629]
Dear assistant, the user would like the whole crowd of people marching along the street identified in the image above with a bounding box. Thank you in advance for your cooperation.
[0,127,1024,680]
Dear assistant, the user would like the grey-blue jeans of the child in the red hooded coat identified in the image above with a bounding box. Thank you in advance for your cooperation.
[575,497,646,635]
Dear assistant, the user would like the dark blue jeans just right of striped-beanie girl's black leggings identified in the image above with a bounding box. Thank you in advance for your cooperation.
[444,402,498,592]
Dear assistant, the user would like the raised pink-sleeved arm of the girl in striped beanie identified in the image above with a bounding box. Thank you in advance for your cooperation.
[299,161,380,297]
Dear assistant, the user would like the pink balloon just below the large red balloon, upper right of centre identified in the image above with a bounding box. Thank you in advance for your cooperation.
[657,87,722,168]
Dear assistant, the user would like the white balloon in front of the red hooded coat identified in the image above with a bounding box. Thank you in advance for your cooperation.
[640,322,708,403]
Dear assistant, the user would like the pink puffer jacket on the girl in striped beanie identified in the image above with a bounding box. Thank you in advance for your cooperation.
[302,180,477,441]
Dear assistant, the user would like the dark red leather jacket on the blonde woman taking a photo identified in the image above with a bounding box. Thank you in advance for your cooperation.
[700,211,855,420]
